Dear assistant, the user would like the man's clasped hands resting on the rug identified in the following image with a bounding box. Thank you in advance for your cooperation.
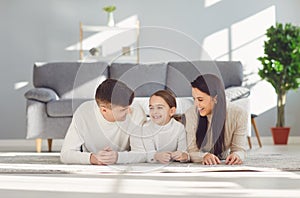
[90,146,118,165]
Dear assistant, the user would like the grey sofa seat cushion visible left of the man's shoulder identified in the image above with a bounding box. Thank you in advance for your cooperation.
[46,99,90,117]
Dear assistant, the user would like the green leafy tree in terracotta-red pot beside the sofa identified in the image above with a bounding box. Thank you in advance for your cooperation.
[258,23,300,144]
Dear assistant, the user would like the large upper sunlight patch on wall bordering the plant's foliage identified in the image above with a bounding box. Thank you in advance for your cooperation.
[230,6,276,73]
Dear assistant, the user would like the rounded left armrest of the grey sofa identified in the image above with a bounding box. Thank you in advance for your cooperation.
[24,88,58,102]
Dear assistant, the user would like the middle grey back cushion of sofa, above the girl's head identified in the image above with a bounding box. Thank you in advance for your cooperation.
[109,63,167,97]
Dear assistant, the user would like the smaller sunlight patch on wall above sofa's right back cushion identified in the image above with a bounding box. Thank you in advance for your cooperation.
[203,29,230,60]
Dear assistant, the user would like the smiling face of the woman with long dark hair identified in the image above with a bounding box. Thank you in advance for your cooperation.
[192,87,217,116]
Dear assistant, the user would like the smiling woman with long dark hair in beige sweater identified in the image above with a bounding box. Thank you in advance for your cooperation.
[185,74,250,165]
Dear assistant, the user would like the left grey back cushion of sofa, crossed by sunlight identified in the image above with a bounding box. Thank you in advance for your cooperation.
[33,62,108,99]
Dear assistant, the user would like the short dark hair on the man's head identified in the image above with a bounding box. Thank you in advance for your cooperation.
[95,79,134,107]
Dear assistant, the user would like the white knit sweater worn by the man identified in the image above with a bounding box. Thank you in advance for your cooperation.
[61,100,146,164]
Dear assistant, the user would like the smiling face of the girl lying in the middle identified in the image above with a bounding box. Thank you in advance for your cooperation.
[149,95,176,125]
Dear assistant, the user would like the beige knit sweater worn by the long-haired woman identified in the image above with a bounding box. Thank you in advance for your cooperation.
[185,103,250,162]
